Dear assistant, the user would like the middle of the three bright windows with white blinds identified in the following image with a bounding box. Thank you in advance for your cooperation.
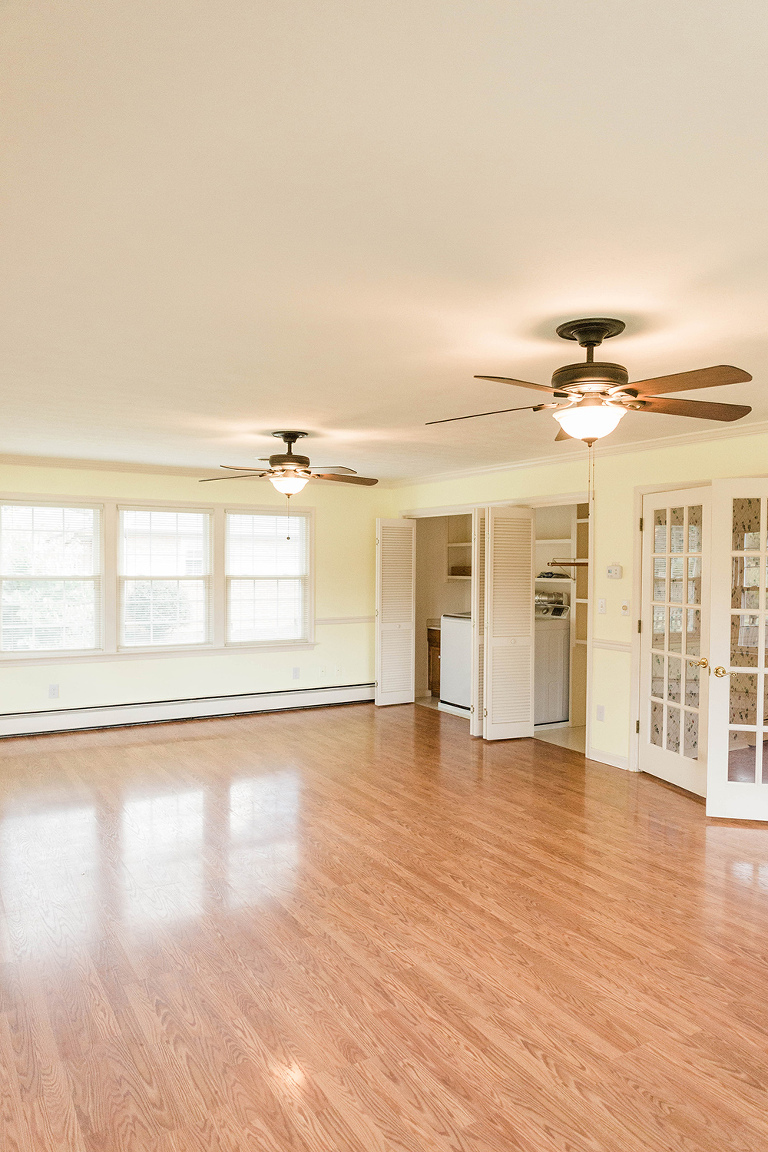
[119,508,212,647]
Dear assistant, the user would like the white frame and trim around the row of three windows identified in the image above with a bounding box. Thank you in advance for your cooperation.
[0,492,315,668]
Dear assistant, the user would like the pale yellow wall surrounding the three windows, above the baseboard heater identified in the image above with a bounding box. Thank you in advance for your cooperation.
[0,464,380,712]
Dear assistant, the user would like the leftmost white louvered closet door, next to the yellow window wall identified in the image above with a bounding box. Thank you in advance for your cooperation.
[375,520,416,704]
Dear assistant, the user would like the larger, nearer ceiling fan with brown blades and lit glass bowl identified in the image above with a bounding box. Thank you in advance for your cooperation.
[428,317,752,445]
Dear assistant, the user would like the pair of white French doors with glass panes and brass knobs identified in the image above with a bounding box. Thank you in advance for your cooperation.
[639,478,768,820]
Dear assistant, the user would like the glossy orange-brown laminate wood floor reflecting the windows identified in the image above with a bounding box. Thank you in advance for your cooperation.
[0,705,768,1152]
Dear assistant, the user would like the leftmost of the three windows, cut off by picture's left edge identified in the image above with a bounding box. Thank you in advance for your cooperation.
[0,503,101,652]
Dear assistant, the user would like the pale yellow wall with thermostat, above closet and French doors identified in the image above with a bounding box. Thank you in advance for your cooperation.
[381,430,768,763]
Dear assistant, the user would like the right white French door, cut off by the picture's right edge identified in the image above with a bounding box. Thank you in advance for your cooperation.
[707,479,768,820]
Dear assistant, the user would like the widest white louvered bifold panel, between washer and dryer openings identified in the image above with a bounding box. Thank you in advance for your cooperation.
[482,508,533,740]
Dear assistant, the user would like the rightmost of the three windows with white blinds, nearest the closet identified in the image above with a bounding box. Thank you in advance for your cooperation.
[226,513,312,644]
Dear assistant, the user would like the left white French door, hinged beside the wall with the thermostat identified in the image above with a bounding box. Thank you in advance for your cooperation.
[639,487,710,796]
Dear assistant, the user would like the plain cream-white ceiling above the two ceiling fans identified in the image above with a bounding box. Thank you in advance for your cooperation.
[0,0,768,477]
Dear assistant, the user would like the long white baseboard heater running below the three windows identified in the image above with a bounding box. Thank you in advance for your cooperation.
[0,684,374,737]
